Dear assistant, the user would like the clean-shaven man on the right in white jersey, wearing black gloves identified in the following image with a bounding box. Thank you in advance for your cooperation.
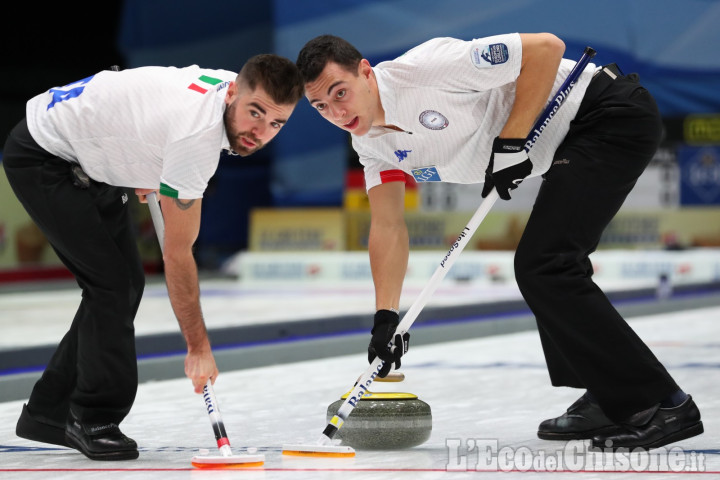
[296,33,703,448]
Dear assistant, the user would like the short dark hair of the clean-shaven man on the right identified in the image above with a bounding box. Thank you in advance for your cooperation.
[295,35,363,83]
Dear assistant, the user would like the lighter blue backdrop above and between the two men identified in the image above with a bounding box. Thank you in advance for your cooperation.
[274,0,720,203]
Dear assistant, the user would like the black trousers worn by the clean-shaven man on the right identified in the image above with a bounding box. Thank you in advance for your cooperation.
[515,66,678,420]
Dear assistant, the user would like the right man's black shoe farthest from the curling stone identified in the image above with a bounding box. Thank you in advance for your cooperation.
[593,395,703,450]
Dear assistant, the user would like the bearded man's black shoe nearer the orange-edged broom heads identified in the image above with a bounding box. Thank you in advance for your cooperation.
[65,415,139,460]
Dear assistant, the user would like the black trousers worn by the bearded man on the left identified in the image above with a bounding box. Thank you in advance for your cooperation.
[3,120,145,426]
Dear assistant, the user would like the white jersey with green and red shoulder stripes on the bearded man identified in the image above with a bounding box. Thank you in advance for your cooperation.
[27,65,237,199]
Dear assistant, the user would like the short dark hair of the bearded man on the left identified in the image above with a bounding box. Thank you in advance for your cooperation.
[237,53,305,105]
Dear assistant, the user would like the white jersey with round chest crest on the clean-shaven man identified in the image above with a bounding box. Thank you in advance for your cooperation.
[352,34,595,190]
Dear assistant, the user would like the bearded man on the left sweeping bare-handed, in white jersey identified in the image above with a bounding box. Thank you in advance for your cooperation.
[3,54,303,460]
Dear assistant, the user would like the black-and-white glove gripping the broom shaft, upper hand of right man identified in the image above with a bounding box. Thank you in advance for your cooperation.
[481,137,532,200]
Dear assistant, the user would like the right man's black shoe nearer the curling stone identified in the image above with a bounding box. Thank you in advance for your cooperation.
[538,395,617,440]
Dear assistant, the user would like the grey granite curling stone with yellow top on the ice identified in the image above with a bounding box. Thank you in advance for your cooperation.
[327,391,432,450]
